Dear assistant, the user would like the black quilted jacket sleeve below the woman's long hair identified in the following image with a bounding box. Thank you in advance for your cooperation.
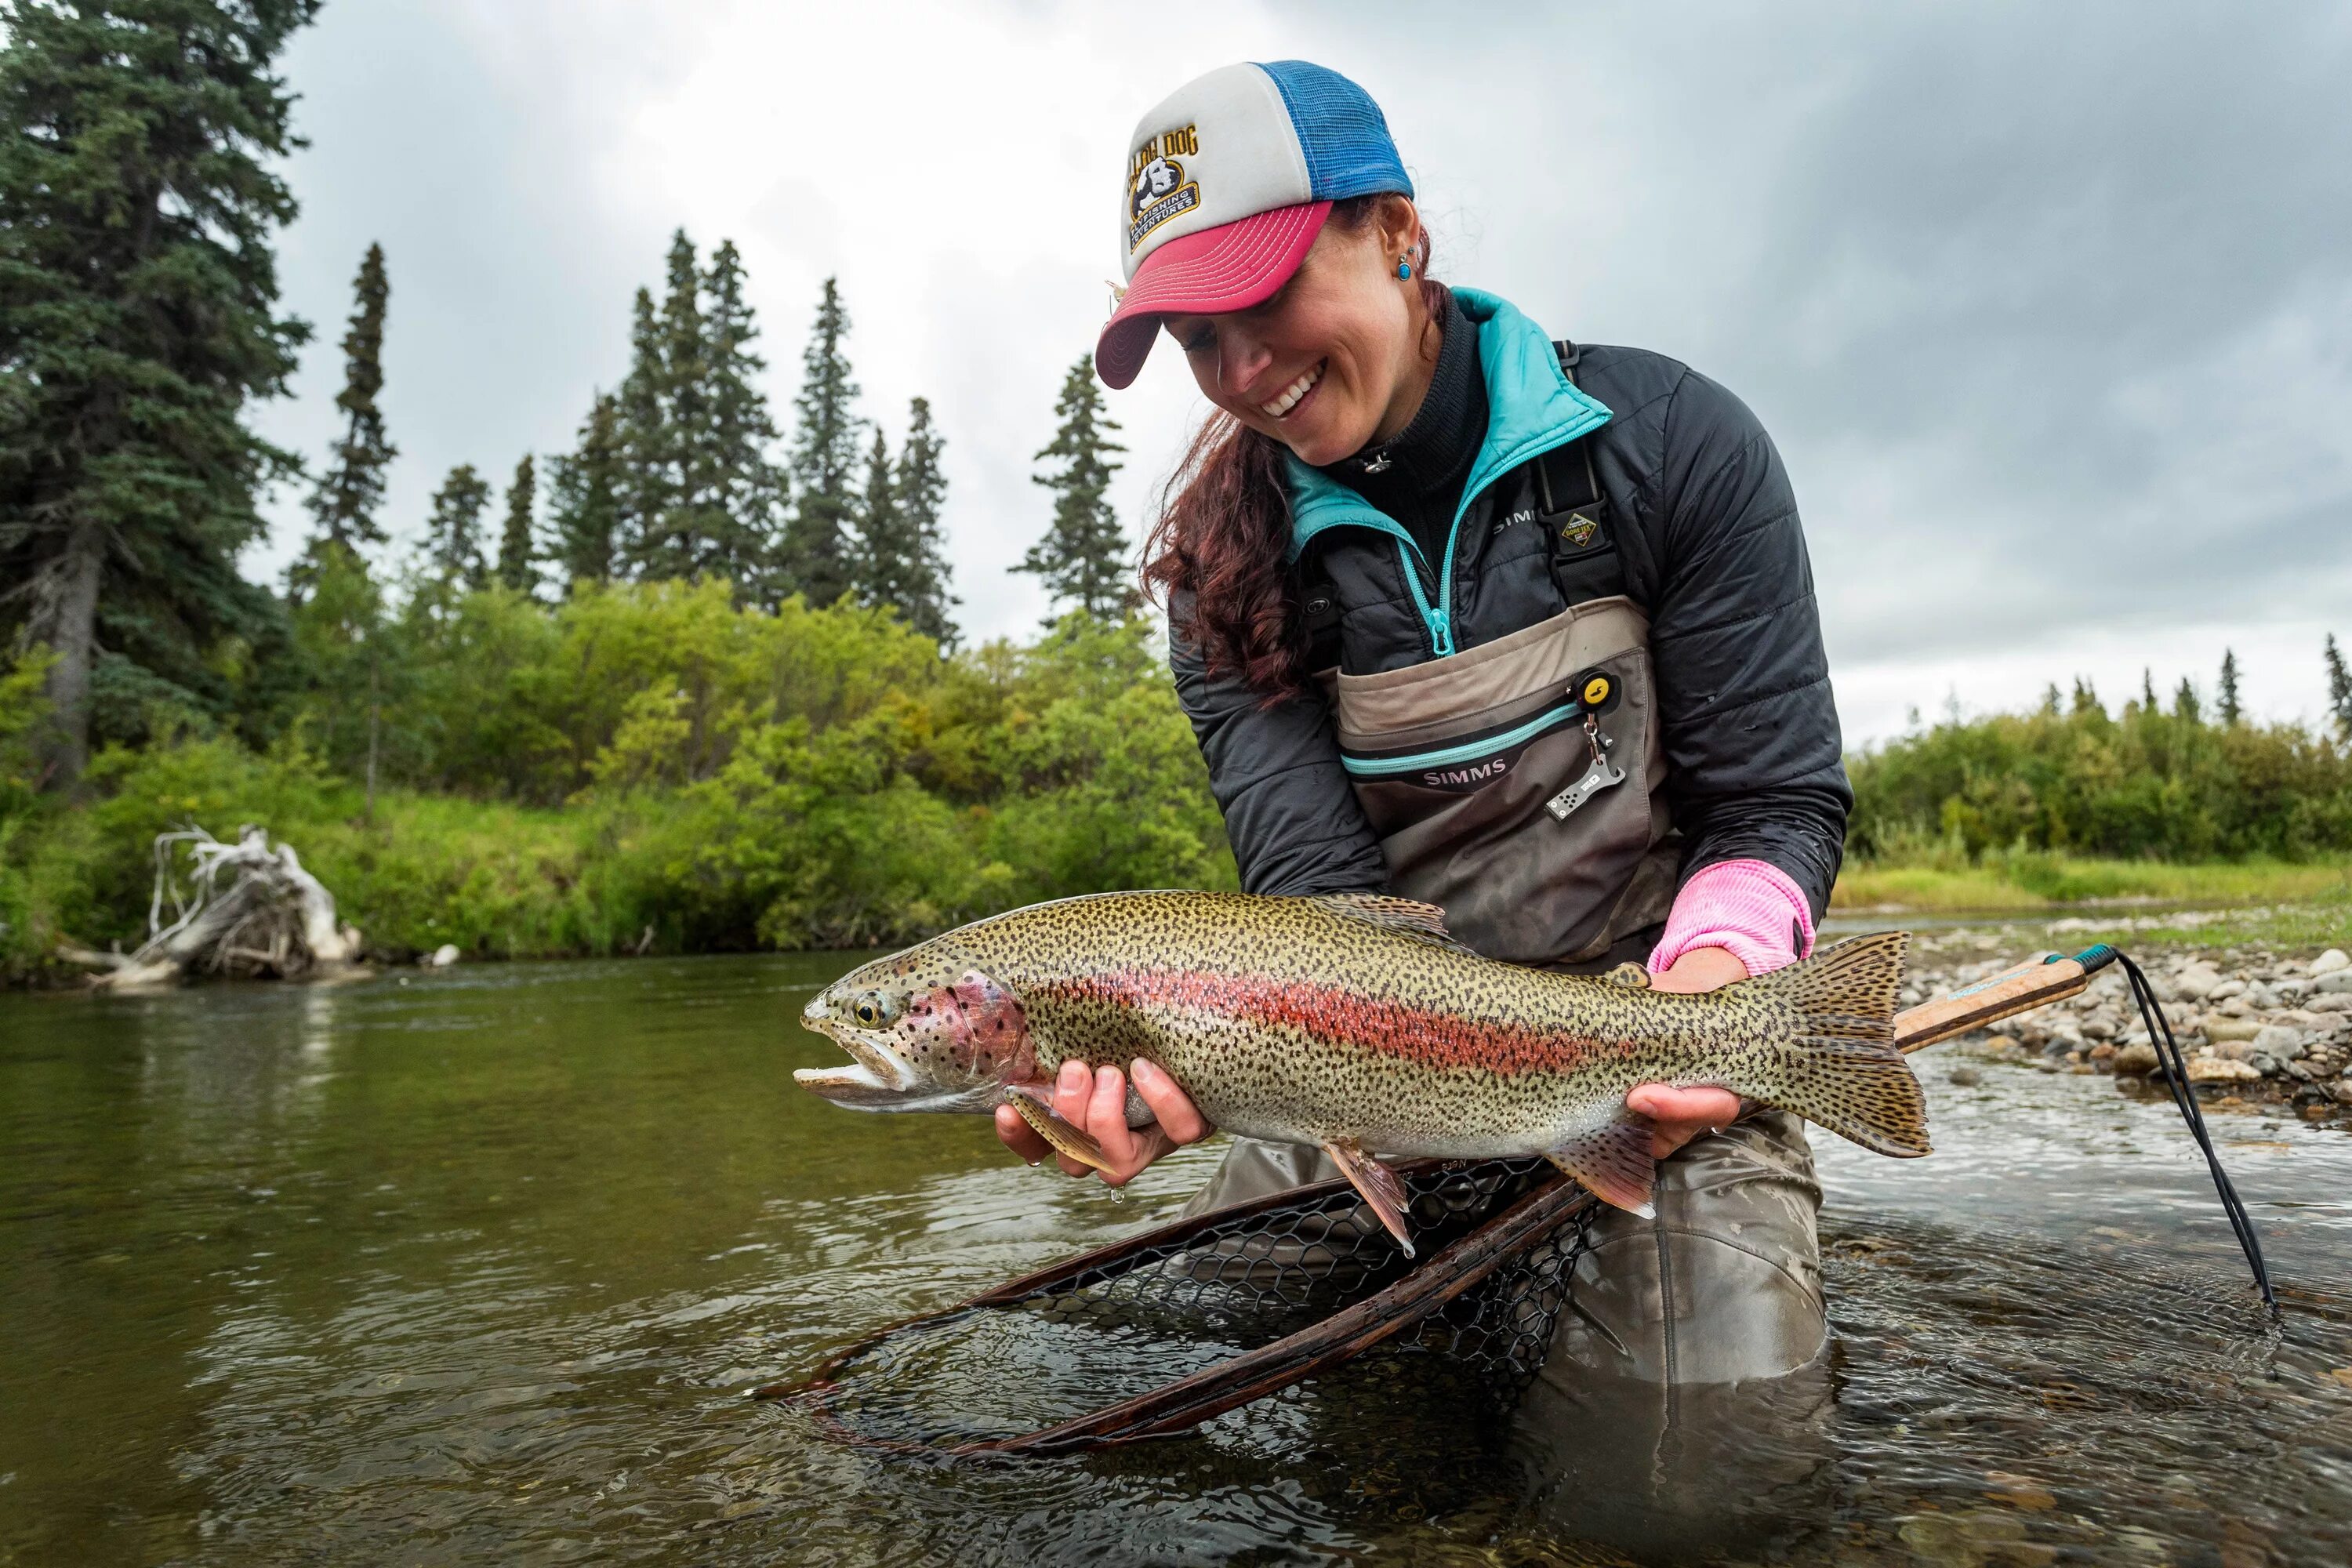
[1169,595,1388,893]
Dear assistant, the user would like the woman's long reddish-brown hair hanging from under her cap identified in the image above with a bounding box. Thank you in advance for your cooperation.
[1143,195,1446,703]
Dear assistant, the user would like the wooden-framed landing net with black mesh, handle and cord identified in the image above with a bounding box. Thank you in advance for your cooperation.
[753,945,2277,1457]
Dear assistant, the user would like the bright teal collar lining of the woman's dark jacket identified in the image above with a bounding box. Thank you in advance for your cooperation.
[1284,289,1609,564]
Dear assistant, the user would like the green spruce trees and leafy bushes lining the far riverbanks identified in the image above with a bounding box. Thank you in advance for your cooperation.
[0,0,2352,978]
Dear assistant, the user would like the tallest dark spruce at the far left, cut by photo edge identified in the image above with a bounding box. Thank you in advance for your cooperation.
[0,0,315,789]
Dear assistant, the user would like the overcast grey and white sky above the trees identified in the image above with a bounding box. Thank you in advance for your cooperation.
[247,0,2352,741]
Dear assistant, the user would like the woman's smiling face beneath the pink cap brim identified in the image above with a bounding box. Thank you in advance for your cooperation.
[1164,200,1435,463]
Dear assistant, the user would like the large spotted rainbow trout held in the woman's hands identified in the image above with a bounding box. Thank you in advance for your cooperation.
[793,893,1929,1250]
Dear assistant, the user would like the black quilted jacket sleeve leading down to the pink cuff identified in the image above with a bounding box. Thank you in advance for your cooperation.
[1646,372,1853,919]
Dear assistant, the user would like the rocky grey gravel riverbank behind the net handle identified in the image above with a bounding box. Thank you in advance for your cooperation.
[1903,931,2352,1121]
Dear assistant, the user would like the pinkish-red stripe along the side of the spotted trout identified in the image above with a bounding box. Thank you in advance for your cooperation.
[1040,968,1632,1074]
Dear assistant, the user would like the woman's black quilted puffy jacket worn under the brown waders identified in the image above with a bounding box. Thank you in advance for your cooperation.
[1171,289,1853,919]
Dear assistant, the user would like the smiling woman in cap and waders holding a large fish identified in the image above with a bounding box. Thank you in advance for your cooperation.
[997,61,1851,1410]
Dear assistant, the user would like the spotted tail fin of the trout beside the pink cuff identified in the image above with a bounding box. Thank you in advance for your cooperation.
[1748,931,1929,1159]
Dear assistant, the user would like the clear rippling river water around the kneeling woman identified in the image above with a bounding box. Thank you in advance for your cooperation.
[0,954,2352,1568]
